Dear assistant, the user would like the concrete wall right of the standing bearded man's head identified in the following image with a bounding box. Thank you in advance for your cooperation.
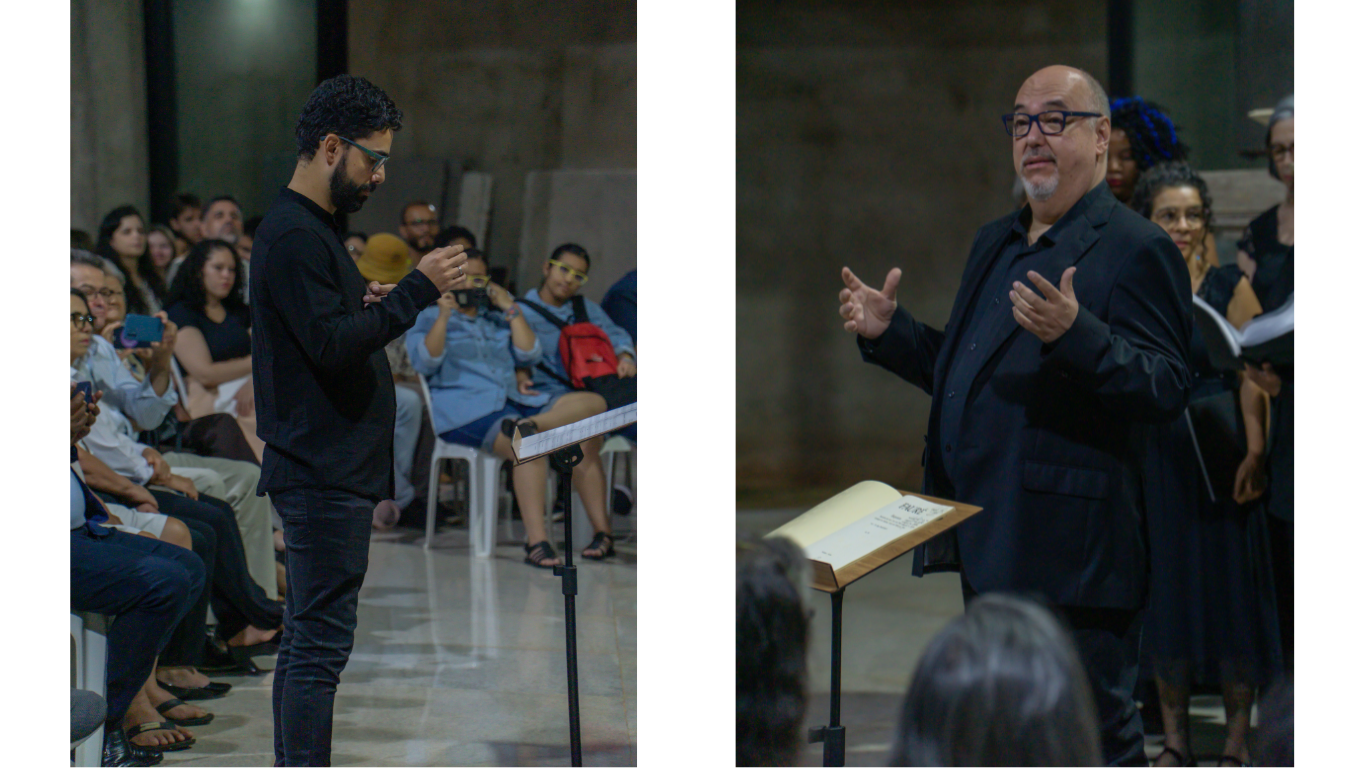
[348,0,635,268]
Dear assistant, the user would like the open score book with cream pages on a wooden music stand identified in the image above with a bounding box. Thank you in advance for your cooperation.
[768,480,982,592]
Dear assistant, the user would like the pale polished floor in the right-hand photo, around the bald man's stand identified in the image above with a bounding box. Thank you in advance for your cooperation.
[736,508,1257,765]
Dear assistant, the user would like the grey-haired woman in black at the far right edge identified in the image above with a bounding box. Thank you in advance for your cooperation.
[1238,94,1295,671]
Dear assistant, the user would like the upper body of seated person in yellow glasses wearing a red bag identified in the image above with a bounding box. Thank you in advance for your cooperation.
[520,243,635,440]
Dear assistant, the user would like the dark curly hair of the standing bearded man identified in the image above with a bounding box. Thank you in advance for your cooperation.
[294,75,403,160]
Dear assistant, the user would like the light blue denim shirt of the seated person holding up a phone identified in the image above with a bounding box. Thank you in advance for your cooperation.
[404,306,550,435]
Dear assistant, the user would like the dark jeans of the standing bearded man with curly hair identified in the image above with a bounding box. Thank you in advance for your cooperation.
[270,489,377,765]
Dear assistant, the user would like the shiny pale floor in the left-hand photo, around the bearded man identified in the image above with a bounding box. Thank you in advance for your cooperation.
[164,517,637,765]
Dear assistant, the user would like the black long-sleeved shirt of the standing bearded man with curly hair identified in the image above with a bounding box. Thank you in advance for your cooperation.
[250,189,440,502]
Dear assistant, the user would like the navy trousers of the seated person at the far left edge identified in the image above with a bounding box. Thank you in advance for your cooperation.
[71,527,205,728]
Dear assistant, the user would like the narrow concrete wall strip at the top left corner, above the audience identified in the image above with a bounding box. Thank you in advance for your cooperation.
[71,0,148,236]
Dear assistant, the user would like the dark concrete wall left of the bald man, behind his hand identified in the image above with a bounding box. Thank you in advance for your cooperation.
[736,0,1106,492]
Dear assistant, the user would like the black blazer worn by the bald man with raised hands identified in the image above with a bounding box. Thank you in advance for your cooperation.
[859,183,1191,609]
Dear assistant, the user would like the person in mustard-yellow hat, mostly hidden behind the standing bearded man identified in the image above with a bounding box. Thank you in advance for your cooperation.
[355,232,422,530]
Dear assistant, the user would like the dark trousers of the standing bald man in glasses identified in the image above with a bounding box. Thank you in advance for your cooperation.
[959,574,1147,765]
